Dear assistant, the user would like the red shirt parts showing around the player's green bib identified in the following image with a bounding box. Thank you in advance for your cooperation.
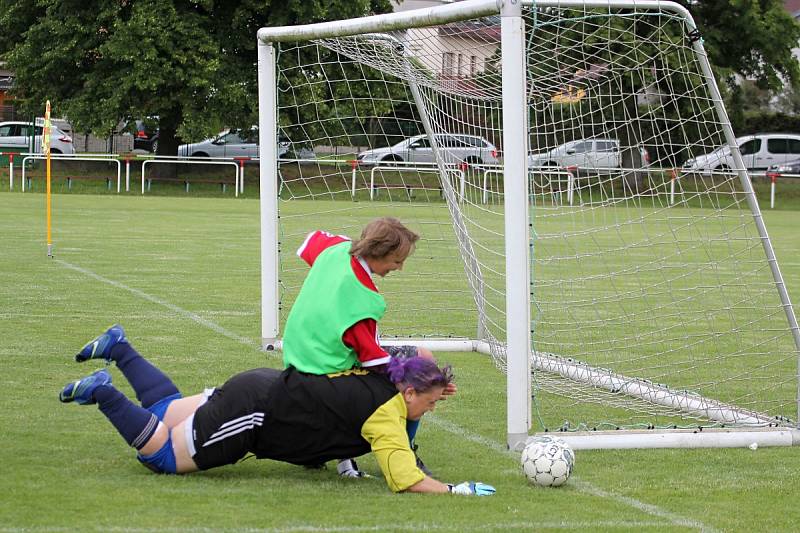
[297,231,389,367]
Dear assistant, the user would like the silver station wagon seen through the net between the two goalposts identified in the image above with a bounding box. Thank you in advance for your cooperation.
[358,134,498,165]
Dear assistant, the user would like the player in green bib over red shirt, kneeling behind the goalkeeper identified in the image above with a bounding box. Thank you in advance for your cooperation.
[283,217,456,477]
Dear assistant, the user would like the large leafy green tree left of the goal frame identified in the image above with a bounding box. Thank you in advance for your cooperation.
[0,0,391,162]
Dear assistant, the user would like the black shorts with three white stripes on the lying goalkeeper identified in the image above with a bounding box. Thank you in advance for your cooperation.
[186,368,281,470]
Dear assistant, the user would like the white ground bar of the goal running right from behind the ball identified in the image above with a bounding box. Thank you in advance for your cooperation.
[527,427,800,450]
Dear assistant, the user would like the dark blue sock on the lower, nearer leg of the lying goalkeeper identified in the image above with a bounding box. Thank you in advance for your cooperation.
[94,385,158,450]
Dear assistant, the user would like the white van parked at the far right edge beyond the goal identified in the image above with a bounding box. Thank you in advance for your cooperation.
[683,133,800,174]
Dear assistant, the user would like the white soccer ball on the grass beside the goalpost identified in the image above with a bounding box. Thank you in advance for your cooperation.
[521,437,575,487]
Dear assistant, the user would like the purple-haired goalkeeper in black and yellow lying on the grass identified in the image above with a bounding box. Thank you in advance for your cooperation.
[59,325,494,495]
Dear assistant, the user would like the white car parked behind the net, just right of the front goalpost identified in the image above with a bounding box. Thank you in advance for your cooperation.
[528,137,650,170]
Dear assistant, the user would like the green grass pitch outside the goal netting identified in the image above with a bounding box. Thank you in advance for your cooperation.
[0,193,800,532]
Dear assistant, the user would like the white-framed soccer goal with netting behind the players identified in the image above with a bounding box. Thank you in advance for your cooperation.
[258,0,800,448]
